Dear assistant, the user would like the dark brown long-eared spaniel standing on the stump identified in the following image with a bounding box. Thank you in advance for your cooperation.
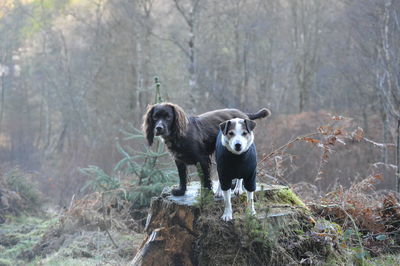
[143,103,271,196]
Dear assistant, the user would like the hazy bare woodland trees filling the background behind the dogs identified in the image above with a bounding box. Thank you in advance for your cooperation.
[0,0,400,206]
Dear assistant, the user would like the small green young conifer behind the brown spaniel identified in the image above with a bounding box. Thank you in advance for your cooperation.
[81,77,177,208]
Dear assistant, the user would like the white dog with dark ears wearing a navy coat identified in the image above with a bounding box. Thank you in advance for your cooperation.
[215,118,257,221]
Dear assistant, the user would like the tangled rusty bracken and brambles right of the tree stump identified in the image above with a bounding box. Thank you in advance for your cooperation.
[258,113,400,265]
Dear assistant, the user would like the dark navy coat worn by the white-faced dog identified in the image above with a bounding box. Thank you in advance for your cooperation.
[215,131,257,192]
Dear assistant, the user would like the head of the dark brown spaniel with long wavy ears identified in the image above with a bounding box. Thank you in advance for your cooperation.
[143,103,188,146]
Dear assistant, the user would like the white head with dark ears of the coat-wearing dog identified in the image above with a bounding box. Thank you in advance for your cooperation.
[219,118,256,154]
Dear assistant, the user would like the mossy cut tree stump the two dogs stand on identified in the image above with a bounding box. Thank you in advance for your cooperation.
[130,182,324,266]
